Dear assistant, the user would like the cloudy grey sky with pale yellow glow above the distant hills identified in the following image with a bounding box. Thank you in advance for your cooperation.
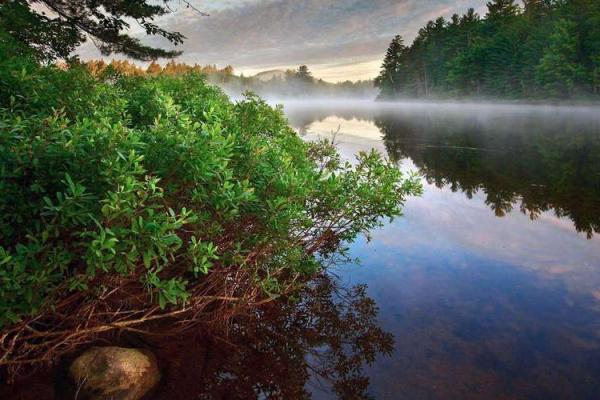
[80,0,487,82]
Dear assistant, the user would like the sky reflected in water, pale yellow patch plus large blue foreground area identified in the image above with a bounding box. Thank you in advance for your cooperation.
[292,104,600,399]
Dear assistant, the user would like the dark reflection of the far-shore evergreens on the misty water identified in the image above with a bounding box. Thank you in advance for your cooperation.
[376,113,600,237]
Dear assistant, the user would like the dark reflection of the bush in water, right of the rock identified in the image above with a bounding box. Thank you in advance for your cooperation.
[152,277,393,399]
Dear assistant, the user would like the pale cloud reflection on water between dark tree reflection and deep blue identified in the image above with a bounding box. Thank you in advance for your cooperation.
[374,159,600,300]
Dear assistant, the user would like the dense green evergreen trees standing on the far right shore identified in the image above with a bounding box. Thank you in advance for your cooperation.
[375,0,600,99]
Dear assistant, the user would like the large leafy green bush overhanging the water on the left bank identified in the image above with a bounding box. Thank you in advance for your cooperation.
[0,33,419,360]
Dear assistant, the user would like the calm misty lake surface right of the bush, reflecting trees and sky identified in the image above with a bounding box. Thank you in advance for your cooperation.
[286,102,600,399]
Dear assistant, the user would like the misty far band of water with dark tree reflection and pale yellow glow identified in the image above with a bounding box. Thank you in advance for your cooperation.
[288,103,600,237]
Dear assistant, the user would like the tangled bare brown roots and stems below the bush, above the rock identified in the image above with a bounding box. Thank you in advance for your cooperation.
[0,268,297,379]
